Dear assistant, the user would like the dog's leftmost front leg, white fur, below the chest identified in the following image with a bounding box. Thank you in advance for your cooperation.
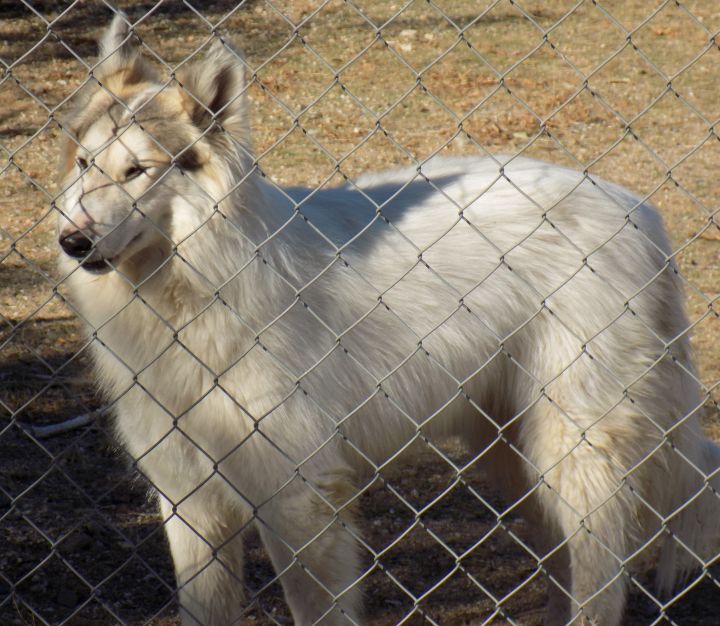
[160,496,249,626]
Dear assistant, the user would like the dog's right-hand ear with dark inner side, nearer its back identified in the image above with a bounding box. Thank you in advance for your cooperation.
[177,39,247,141]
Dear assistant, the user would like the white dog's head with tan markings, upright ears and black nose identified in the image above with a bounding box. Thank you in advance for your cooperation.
[57,15,251,273]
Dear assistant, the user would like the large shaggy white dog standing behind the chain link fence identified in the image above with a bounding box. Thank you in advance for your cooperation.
[58,16,720,625]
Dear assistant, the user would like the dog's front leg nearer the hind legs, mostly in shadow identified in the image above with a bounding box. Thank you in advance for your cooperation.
[257,472,361,626]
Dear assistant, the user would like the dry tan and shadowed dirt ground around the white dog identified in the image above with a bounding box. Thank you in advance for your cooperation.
[0,0,720,625]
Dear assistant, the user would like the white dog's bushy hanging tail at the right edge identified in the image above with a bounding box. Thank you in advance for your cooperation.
[657,437,720,596]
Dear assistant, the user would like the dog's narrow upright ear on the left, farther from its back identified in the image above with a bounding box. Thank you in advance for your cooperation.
[93,12,155,86]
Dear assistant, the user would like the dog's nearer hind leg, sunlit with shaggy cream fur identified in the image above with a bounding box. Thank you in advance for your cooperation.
[522,407,637,626]
